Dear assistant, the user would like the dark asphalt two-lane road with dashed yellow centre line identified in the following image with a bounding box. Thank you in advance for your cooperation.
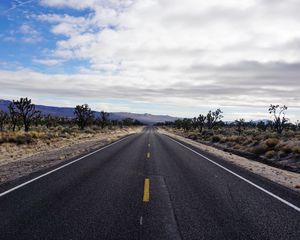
[0,127,300,240]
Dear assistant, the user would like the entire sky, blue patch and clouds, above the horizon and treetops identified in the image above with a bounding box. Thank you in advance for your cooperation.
[0,0,300,122]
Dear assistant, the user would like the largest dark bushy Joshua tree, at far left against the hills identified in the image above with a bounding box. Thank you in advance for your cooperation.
[13,97,40,132]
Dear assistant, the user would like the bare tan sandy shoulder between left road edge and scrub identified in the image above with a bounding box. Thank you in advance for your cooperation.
[0,127,143,184]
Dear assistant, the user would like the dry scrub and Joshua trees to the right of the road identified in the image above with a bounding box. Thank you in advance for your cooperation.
[157,104,300,172]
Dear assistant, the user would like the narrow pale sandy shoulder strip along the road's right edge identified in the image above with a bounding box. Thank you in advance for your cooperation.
[158,128,300,192]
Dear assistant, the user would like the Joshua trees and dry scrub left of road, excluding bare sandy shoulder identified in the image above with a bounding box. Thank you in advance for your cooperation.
[0,98,142,145]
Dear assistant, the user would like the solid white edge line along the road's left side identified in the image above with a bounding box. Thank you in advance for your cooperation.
[0,136,130,197]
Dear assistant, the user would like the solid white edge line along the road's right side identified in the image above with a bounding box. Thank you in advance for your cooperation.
[165,135,300,212]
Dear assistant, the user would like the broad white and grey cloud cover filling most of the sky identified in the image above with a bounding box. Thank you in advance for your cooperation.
[0,0,300,118]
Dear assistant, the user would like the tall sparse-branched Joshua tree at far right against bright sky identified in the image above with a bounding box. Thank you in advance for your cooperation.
[269,104,288,134]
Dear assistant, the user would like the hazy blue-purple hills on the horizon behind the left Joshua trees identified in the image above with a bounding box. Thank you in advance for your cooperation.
[0,100,178,124]
